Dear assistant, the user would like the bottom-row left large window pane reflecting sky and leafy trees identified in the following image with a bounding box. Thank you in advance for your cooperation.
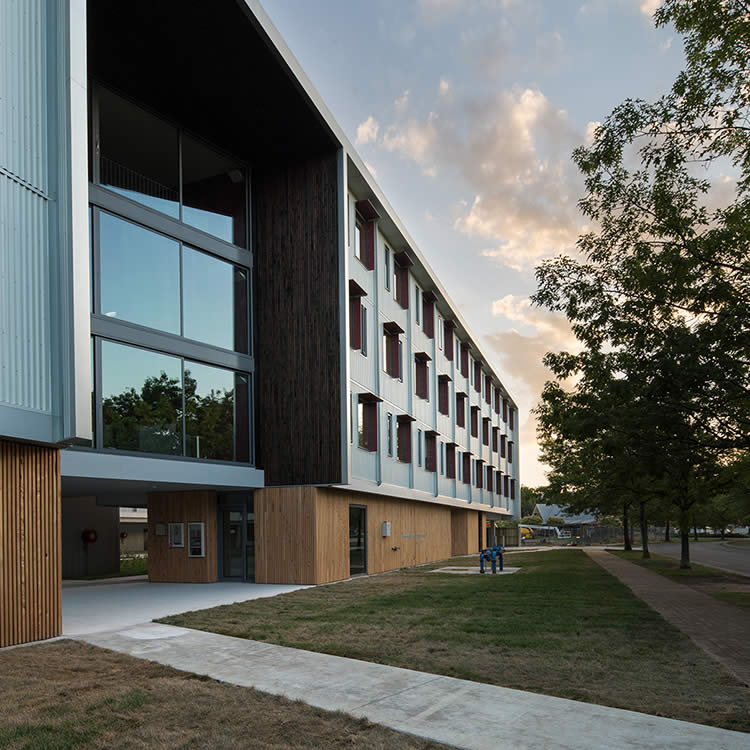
[101,341,182,456]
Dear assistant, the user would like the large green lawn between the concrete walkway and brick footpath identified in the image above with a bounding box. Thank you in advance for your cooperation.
[162,550,750,731]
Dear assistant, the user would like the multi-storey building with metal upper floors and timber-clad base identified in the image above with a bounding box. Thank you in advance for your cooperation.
[0,0,519,645]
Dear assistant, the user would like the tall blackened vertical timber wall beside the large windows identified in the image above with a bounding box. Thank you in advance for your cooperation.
[253,152,347,485]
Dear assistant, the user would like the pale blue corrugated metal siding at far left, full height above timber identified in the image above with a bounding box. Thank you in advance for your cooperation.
[0,0,52,413]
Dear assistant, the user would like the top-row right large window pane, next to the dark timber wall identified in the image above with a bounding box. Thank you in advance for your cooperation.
[182,135,247,247]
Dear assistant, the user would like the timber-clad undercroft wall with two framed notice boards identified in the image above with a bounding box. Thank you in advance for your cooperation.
[148,491,219,583]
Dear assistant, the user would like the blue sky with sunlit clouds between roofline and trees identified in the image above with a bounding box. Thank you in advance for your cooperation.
[262,0,684,486]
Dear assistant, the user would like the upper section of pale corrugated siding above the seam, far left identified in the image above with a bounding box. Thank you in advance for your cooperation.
[0,0,48,197]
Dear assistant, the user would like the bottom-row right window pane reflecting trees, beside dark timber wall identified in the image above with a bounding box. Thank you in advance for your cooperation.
[185,361,250,461]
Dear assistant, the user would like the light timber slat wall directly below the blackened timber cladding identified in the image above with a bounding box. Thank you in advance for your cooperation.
[253,487,318,584]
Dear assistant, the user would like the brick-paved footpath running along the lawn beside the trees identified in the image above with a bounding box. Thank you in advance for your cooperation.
[584,547,750,687]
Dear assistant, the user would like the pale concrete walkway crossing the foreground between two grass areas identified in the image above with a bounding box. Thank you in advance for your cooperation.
[77,623,750,750]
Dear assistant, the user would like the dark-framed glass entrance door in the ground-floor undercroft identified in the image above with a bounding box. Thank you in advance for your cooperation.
[219,495,255,583]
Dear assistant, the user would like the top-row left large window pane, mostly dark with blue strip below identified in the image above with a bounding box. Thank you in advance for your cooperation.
[99,89,180,218]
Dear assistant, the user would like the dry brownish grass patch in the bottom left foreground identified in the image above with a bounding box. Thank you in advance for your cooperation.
[0,641,452,750]
